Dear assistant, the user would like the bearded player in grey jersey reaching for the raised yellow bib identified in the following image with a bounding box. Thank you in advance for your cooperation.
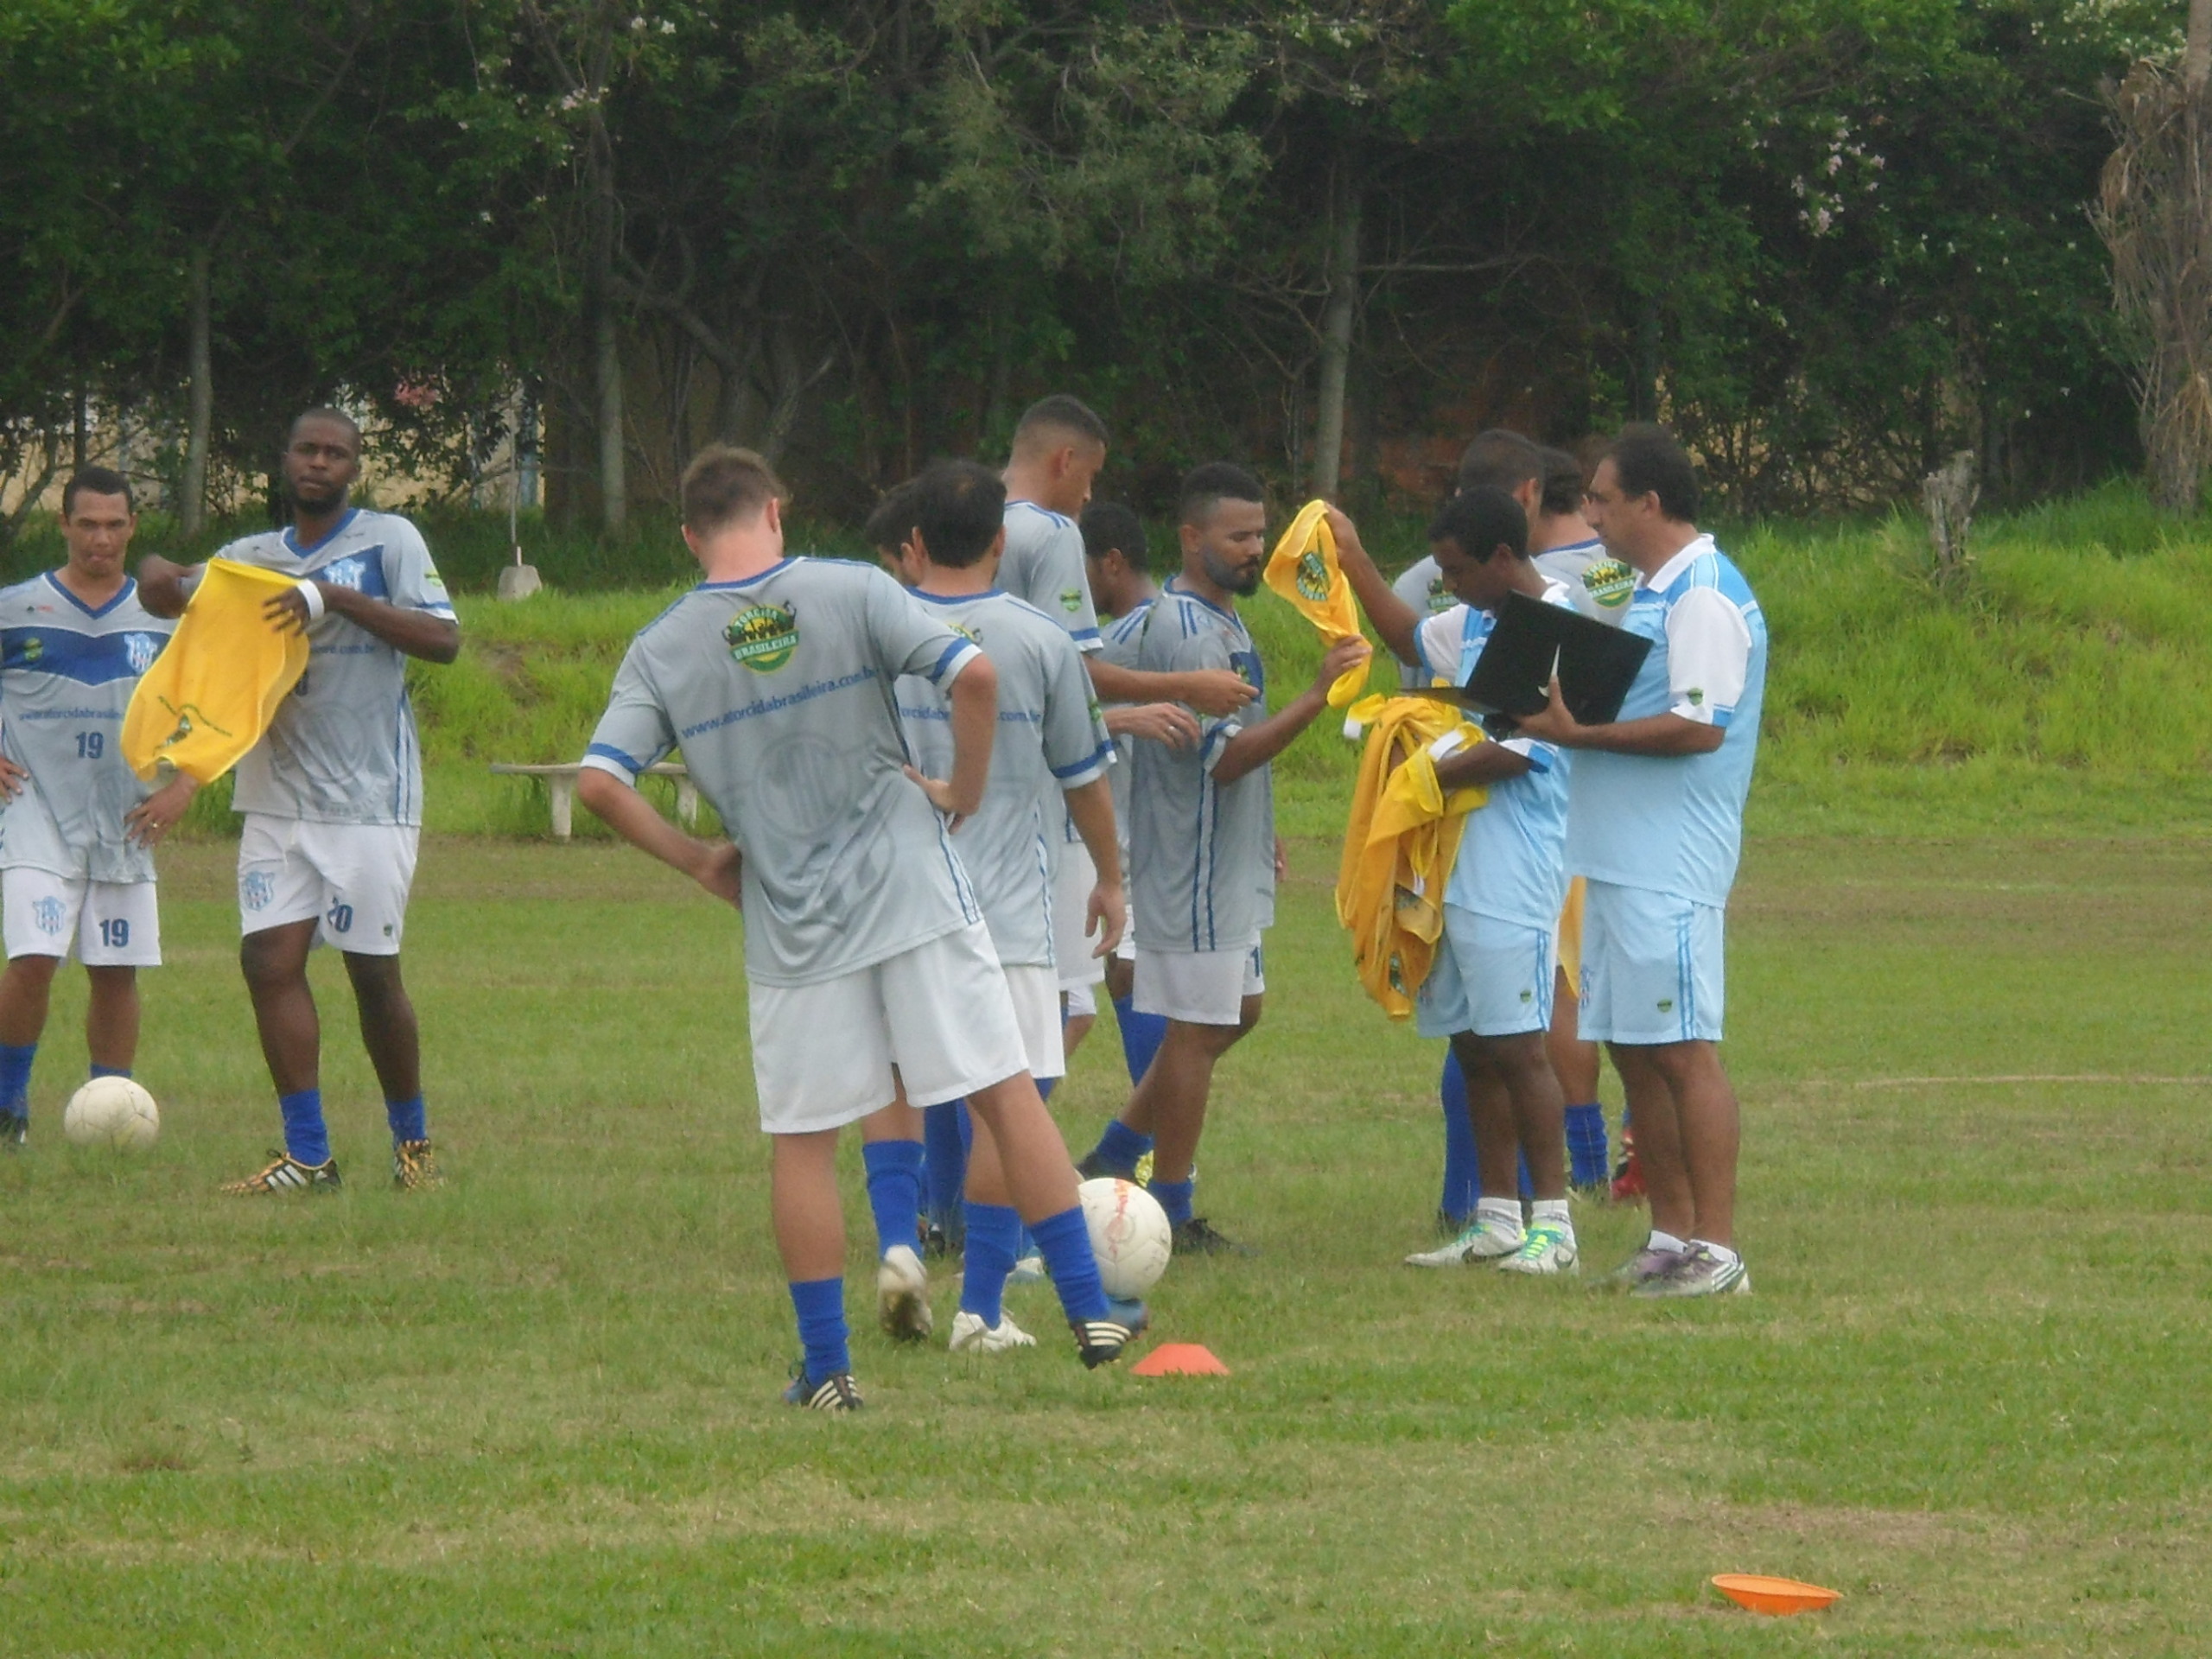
[1090,462,1367,1252]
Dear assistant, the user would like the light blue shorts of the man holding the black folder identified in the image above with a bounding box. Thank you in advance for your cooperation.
[1575,880,1727,1044]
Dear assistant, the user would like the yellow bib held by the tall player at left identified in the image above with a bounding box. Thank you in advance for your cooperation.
[124,560,308,783]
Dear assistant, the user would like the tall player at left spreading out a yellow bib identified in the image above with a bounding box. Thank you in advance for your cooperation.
[139,410,460,1194]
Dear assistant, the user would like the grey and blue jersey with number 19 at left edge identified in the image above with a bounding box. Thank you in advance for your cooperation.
[0,573,177,882]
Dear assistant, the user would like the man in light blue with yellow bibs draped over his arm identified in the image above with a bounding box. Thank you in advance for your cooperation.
[1330,486,1577,1274]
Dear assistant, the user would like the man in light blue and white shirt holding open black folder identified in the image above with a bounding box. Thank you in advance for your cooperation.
[1522,427,1767,1296]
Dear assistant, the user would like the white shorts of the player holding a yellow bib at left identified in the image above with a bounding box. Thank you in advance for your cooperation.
[238,812,420,956]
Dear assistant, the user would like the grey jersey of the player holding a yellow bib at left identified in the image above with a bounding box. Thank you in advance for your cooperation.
[219,506,454,825]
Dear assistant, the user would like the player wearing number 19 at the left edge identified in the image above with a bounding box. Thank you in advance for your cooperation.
[0,467,197,1148]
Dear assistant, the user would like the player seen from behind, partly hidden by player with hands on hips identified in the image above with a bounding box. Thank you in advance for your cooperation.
[865,460,1123,1354]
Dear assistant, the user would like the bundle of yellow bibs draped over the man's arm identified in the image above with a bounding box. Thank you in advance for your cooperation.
[1336,696,1489,1020]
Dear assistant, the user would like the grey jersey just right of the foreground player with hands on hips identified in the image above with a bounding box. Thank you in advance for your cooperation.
[898,593,1113,967]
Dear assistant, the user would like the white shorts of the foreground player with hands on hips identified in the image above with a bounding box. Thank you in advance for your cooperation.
[746,923,1030,1135]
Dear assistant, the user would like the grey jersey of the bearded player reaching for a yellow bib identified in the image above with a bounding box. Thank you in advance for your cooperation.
[1128,582,1274,951]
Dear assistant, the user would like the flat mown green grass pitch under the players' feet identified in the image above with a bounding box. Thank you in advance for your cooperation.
[0,836,2212,1656]
